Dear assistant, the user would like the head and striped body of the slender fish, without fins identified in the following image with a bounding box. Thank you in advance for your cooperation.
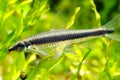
[9,28,114,52]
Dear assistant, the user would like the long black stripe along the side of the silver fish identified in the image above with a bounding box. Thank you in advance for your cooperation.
[29,30,114,45]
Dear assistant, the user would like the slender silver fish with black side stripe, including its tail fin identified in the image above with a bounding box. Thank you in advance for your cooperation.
[8,15,120,52]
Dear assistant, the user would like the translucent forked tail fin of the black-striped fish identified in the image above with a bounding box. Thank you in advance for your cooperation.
[103,15,120,41]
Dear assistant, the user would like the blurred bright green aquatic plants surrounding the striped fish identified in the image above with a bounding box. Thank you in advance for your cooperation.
[0,0,120,80]
